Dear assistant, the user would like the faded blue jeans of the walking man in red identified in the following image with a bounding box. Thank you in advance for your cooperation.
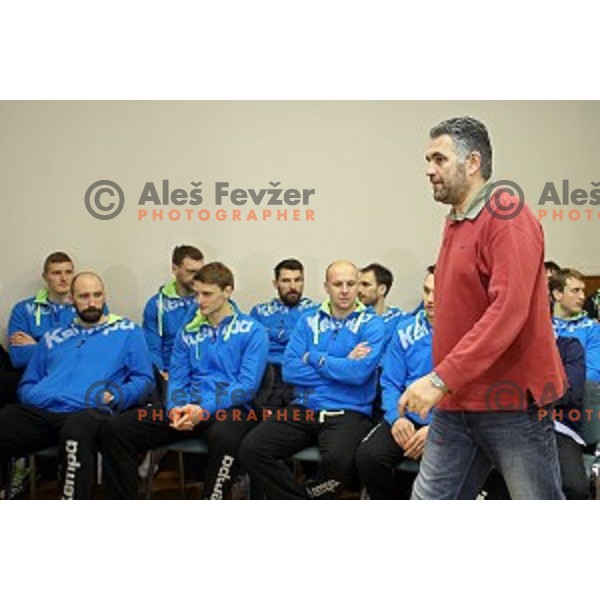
[412,405,564,500]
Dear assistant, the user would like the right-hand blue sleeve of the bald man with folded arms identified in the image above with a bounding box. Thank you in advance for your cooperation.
[308,317,385,385]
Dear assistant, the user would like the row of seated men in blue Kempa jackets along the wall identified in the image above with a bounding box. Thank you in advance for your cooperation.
[0,246,598,498]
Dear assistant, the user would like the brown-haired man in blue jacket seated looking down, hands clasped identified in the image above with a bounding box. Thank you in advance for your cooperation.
[102,262,268,499]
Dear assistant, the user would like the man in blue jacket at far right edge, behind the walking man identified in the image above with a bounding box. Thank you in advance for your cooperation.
[548,269,600,381]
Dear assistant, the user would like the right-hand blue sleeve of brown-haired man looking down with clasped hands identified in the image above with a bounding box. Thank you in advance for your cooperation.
[217,322,269,408]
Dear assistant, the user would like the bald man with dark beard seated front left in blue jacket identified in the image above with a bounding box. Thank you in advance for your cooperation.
[0,273,154,499]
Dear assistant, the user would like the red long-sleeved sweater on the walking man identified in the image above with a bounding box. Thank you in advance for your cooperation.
[433,186,565,411]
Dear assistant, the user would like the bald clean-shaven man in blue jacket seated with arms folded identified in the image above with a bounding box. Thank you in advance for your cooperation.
[240,261,385,499]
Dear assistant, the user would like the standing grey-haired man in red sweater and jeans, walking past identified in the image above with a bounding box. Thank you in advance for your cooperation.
[400,117,565,499]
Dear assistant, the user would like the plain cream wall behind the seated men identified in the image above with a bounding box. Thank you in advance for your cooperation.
[0,101,600,338]
